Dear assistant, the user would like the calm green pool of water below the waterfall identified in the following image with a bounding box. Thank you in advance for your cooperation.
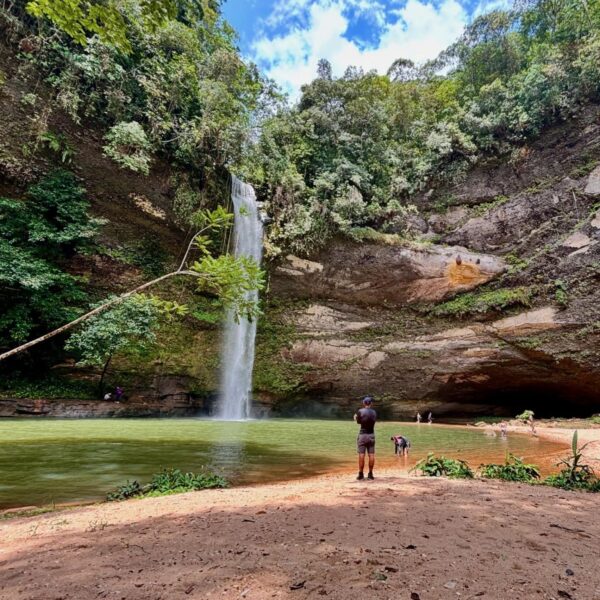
[0,419,564,508]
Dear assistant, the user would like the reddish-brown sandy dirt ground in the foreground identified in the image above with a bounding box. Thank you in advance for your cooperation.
[0,432,600,600]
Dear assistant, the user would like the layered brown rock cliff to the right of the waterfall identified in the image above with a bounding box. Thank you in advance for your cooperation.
[257,109,600,417]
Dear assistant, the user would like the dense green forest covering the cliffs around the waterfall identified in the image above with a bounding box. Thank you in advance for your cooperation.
[0,0,600,412]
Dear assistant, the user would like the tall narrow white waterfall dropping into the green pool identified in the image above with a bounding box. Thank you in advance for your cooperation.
[218,175,263,421]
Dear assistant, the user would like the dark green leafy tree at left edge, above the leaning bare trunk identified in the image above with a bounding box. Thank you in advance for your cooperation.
[0,171,102,346]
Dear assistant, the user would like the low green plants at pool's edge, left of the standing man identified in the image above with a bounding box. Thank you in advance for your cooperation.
[107,469,227,501]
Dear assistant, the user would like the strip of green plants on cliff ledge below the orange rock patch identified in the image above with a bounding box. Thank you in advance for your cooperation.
[431,287,533,317]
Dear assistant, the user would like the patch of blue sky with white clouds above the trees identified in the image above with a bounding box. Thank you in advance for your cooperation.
[223,0,509,99]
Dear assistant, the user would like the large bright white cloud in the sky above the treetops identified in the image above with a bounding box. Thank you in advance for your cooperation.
[253,0,468,99]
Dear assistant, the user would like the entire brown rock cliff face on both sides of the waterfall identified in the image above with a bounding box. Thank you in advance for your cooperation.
[0,27,600,417]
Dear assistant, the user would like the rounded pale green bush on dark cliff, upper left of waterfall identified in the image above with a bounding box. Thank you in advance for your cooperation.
[104,121,151,175]
